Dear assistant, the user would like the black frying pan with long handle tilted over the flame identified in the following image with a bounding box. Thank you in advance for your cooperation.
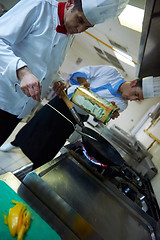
[61,91,124,166]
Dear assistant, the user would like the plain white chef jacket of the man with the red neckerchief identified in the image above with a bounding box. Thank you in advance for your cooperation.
[0,0,73,118]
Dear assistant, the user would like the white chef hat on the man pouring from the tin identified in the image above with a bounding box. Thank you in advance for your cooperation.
[142,76,160,98]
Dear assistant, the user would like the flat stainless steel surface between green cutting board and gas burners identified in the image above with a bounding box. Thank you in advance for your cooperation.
[28,154,158,240]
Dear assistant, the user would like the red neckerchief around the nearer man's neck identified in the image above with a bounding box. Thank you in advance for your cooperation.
[56,2,67,34]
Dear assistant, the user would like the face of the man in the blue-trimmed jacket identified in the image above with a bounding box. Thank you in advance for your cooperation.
[122,80,144,101]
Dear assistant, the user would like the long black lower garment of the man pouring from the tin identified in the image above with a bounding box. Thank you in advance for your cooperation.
[12,96,75,168]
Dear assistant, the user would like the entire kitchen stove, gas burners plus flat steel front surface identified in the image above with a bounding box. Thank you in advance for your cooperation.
[19,141,160,240]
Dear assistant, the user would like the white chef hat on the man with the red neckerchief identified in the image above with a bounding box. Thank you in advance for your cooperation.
[82,0,129,25]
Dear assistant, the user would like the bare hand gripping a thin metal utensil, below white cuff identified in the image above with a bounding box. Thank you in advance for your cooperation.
[17,66,42,102]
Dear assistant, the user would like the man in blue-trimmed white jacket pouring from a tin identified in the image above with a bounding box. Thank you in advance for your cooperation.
[0,65,160,167]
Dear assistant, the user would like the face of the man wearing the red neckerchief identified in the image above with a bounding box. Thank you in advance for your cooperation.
[64,0,93,34]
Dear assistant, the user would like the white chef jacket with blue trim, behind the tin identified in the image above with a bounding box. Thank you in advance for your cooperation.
[67,65,128,115]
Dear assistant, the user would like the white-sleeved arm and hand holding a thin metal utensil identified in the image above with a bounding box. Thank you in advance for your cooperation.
[0,1,46,101]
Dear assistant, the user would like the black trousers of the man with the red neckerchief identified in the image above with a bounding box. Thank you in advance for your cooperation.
[0,109,21,146]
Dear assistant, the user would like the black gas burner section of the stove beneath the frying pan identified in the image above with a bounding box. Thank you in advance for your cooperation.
[66,141,160,221]
